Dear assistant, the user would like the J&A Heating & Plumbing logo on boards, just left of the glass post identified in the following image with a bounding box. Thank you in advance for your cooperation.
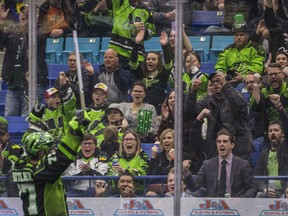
[114,200,164,216]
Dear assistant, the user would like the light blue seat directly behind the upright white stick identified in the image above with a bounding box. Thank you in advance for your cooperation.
[63,37,100,64]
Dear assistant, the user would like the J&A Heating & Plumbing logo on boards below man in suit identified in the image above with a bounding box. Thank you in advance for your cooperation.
[190,200,240,216]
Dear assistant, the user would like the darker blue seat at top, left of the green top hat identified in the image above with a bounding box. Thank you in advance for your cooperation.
[191,10,224,34]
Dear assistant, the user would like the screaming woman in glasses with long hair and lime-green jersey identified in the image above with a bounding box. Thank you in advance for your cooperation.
[108,131,149,176]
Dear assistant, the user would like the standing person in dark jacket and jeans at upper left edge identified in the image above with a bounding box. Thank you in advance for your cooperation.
[0,2,29,116]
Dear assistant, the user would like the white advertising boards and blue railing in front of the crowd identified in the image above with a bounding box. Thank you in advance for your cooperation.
[0,176,288,216]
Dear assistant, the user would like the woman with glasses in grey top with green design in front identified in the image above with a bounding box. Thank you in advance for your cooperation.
[120,81,156,142]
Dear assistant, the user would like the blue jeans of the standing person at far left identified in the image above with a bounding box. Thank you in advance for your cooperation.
[5,89,29,116]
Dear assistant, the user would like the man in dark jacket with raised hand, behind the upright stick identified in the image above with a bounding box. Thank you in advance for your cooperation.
[55,52,94,109]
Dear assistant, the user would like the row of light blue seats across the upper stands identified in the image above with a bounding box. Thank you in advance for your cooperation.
[46,35,233,64]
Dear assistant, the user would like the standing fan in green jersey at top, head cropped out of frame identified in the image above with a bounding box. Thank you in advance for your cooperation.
[107,0,155,69]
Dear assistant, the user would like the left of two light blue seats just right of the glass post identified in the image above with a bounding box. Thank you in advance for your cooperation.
[188,36,210,62]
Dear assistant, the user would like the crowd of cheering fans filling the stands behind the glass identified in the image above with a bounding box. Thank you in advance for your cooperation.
[0,0,288,211]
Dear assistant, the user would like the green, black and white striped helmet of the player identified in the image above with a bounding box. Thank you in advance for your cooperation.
[23,132,54,158]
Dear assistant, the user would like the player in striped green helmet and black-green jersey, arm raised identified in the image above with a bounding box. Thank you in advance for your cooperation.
[12,111,90,216]
